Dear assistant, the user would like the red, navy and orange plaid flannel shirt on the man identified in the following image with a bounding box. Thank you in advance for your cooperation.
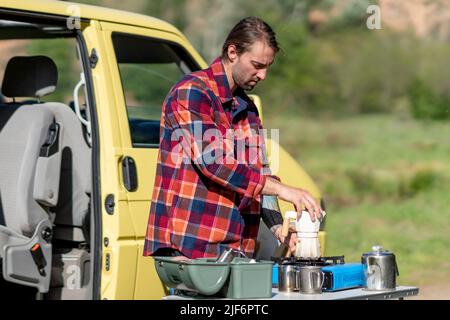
[144,58,270,259]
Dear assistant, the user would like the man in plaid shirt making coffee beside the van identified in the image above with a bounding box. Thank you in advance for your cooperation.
[144,17,322,259]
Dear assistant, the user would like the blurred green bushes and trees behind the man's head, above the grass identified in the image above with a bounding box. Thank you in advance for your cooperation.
[67,0,450,120]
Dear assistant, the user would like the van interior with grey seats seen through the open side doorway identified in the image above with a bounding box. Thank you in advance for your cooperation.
[0,15,93,300]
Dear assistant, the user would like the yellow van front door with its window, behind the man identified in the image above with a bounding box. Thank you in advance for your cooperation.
[85,22,207,299]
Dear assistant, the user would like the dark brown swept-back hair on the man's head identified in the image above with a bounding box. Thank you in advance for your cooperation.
[222,17,280,60]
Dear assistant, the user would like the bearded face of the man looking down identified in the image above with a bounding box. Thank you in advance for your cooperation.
[229,41,275,90]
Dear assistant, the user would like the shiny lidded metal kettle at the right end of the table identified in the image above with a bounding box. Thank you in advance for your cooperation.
[361,246,399,291]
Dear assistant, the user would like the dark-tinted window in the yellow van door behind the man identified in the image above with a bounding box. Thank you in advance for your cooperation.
[112,33,198,148]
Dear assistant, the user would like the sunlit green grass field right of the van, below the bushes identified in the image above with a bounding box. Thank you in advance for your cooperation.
[265,114,450,286]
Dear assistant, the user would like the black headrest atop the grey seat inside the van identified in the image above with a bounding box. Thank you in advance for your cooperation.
[2,56,58,98]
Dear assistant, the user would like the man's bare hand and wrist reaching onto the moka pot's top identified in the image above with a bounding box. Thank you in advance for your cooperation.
[262,177,322,222]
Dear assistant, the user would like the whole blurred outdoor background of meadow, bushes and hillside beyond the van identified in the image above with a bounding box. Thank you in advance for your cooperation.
[49,0,450,298]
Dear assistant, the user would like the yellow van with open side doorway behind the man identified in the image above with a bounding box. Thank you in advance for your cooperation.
[0,0,325,299]
